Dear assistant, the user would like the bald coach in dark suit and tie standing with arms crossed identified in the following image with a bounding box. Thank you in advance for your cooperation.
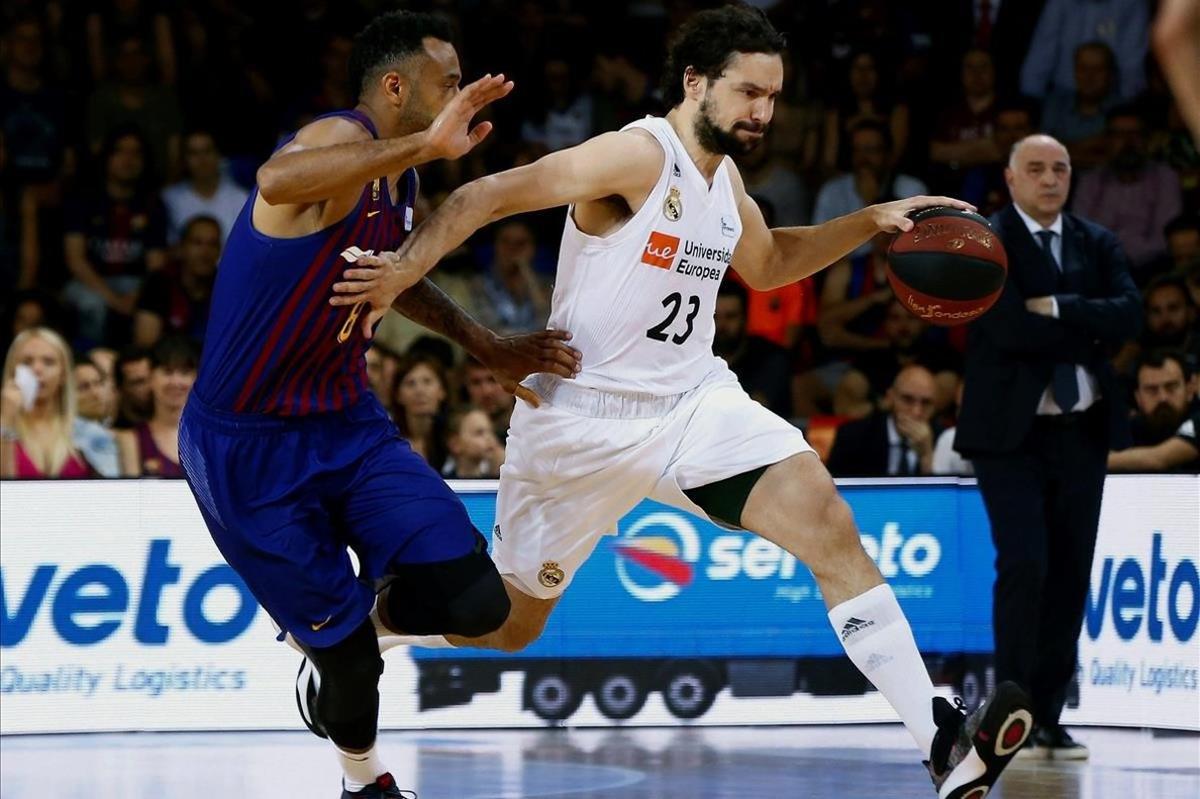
[955,134,1141,759]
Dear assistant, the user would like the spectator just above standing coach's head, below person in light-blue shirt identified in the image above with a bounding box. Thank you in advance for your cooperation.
[1042,42,1120,169]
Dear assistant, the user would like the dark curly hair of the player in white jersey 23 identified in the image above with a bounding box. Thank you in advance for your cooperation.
[661,4,787,108]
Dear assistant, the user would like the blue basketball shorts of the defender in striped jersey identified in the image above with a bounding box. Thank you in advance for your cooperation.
[179,394,479,648]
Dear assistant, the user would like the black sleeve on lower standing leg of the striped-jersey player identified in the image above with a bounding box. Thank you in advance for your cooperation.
[308,619,383,750]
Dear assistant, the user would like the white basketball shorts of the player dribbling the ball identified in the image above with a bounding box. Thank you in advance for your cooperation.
[492,362,812,599]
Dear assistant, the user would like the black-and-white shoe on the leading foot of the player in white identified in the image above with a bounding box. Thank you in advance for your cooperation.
[925,683,1033,799]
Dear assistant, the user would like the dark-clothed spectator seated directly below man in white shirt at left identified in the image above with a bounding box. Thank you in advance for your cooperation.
[133,216,221,347]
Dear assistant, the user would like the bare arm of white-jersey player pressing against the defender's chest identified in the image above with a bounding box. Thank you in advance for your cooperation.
[330,131,666,336]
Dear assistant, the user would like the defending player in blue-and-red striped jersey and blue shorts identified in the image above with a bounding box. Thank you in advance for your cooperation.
[179,12,577,799]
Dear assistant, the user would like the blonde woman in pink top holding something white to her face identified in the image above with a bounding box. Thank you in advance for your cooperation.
[0,328,118,479]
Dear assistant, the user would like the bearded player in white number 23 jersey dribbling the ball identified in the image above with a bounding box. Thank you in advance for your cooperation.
[331,6,1032,799]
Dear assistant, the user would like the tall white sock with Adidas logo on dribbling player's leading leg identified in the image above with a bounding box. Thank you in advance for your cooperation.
[829,584,937,759]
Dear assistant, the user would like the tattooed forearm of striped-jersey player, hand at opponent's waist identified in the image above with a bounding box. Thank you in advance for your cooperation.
[391,278,580,407]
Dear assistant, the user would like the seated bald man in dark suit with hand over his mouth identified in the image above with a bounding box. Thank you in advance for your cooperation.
[827,364,937,477]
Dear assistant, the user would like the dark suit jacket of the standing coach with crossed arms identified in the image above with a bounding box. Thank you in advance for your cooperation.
[954,204,1141,457]
